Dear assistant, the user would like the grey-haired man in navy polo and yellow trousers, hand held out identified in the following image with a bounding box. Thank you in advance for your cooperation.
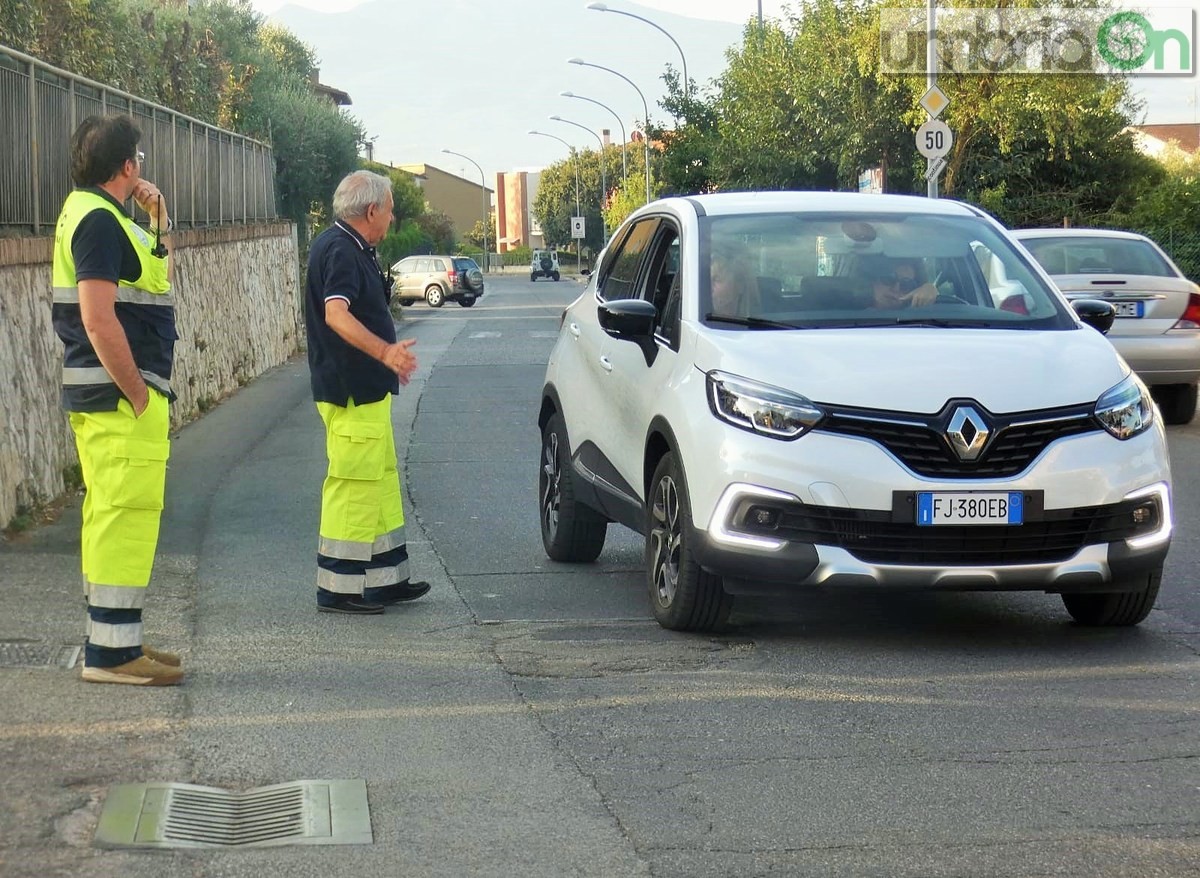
[305,170,430,615]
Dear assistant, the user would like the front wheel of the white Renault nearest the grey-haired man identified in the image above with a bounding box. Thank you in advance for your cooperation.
[646,452,733,631]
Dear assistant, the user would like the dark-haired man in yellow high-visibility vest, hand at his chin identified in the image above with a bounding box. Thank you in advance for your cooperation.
[52,115,184,686]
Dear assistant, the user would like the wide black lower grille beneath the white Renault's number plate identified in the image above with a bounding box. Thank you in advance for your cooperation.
[763,499,1157,566]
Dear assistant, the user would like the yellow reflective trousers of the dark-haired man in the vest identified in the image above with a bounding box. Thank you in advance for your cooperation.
[70,387,170,667]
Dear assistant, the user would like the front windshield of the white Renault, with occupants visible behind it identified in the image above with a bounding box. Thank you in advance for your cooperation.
[700,212,1076,331]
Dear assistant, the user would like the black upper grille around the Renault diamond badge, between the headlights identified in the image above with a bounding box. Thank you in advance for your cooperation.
[817,401,1102,479]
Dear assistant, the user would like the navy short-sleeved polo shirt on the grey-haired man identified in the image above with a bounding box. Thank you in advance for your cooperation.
[305,222,400,407]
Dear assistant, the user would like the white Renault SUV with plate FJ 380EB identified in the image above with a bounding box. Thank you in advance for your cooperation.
[539,192,1172,630]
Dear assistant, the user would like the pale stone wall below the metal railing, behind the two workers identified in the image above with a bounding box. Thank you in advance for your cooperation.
[0,223,304,527]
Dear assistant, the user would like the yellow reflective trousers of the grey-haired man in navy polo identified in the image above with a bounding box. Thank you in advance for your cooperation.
[317,395,408,599]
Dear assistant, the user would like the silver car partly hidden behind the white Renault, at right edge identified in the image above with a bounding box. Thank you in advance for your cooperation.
[1013,229,1200,423]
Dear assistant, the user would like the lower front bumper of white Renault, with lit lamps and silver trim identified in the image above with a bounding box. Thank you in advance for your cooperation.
[692,485,1172,594]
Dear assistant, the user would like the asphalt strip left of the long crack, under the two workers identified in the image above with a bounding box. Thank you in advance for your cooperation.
[0,333,646,878]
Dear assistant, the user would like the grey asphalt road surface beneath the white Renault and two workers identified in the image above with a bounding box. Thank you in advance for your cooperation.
[0,275,1200,878]
